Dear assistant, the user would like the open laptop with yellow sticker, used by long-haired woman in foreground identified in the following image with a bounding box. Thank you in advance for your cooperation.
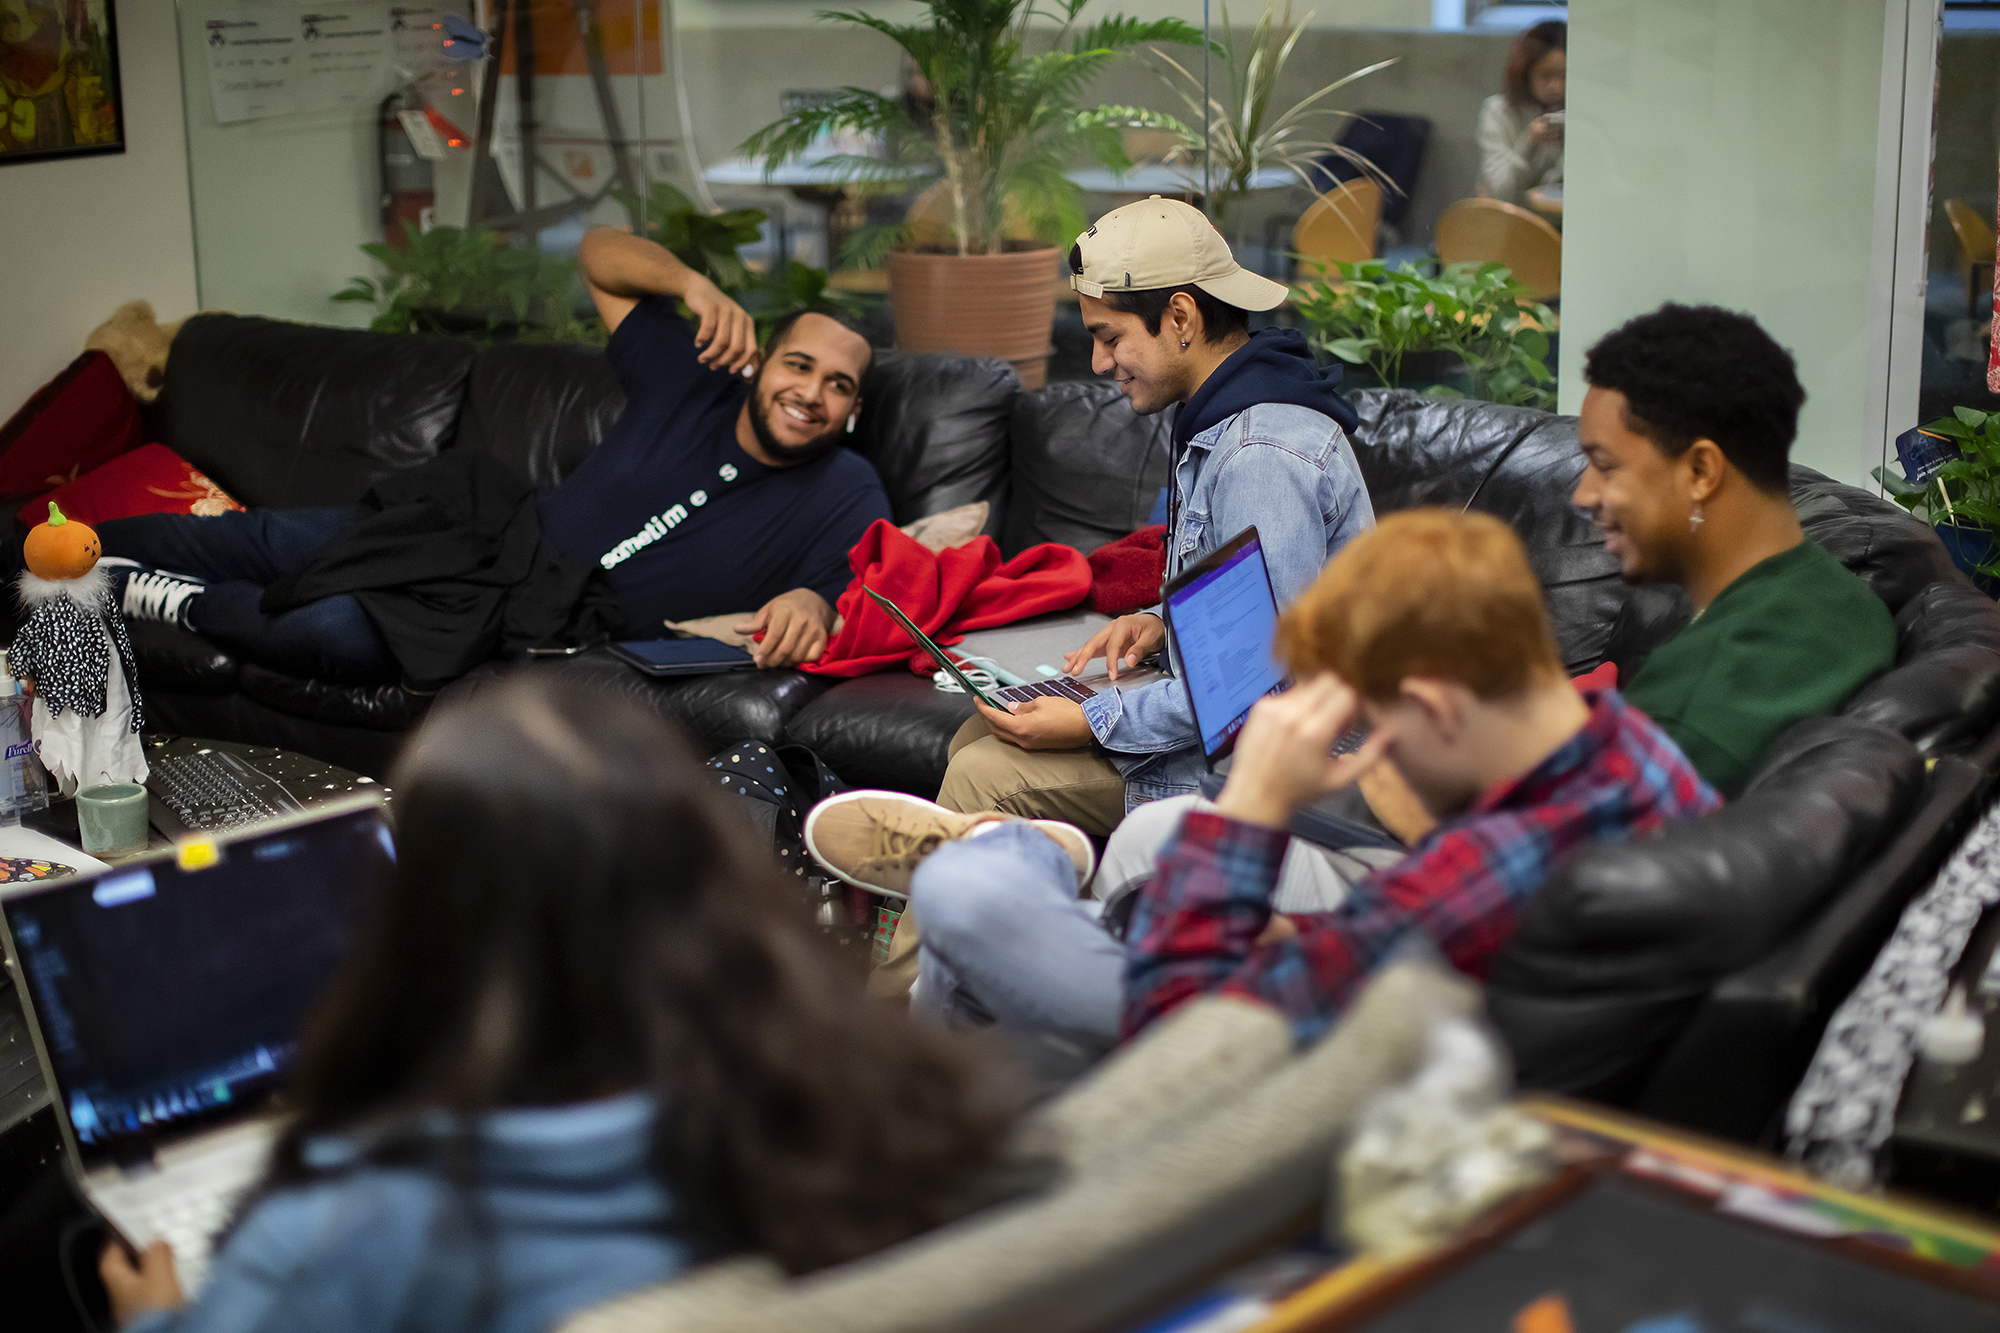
[0,793,392,1295]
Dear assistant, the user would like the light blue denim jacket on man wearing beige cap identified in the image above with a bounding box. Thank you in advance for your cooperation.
[1084,402,1374,811]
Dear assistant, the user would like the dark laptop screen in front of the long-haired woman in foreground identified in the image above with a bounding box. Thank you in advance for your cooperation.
[6,809,390,1153]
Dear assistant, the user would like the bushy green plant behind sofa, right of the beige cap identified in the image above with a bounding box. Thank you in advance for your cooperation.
[1298,260,1556,410]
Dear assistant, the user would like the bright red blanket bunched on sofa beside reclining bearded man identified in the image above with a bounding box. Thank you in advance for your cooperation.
[800,518,1090,677]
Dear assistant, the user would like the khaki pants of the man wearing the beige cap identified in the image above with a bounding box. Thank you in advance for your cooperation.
[868,713,1124,999]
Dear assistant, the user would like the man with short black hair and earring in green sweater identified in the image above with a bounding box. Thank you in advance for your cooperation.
[1574,304,1896,797]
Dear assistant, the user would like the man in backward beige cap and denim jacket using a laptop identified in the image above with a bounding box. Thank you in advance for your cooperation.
[938,194,1374,835]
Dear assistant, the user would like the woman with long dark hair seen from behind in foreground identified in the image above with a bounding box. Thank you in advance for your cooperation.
[100,681,1012,1333]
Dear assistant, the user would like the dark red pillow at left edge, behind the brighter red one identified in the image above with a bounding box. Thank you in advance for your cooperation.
[0,352,142,500]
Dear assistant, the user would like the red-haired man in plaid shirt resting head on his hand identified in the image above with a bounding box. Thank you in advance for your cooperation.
[808,508,1720,1073]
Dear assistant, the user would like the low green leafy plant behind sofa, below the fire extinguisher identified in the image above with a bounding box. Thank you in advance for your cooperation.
[334,222,606,342]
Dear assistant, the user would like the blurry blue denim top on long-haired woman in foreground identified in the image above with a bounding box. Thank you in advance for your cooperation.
[124,1093,692,1333]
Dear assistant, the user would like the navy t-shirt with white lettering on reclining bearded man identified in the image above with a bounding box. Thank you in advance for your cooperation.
[540,296,890,634]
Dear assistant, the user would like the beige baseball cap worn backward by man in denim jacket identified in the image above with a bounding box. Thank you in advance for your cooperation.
[1070,194,1288,310]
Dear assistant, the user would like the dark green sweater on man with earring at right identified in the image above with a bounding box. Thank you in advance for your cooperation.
[1626,540,1896,799]
